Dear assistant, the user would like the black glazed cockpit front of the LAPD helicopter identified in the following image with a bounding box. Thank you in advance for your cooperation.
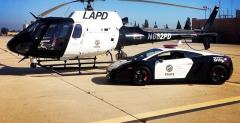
[7,17,73,58]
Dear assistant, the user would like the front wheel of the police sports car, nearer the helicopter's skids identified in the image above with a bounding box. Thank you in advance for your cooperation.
[132,66,152,86]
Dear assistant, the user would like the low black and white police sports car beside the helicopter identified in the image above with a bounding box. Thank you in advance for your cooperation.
[107,48,233,85]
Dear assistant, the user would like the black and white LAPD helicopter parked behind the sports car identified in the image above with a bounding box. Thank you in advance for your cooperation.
[7,0,218,67]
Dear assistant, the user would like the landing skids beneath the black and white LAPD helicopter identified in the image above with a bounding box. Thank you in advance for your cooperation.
[37,54,113,76]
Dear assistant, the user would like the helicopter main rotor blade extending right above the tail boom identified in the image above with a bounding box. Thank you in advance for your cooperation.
[120,0,206,10]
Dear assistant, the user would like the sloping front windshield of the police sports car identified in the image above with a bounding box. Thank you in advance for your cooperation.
[132,48,162,60]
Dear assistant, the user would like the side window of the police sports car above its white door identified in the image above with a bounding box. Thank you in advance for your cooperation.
[158,51,185,60]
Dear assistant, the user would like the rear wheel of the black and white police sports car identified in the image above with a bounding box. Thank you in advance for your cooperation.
[210,65,228,85]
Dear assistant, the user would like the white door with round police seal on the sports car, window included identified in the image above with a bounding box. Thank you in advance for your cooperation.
[155,51,193,79]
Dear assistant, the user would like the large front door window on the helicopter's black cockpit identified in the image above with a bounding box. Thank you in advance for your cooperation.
[38,24,71,50]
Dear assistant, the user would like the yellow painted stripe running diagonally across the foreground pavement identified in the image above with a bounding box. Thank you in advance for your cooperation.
[93,96,240,123]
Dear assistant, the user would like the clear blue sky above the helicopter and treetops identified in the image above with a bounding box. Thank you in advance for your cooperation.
[0,0,240,29]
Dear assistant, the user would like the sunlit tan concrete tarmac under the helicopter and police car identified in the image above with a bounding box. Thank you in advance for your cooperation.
[0,37,240,123]
